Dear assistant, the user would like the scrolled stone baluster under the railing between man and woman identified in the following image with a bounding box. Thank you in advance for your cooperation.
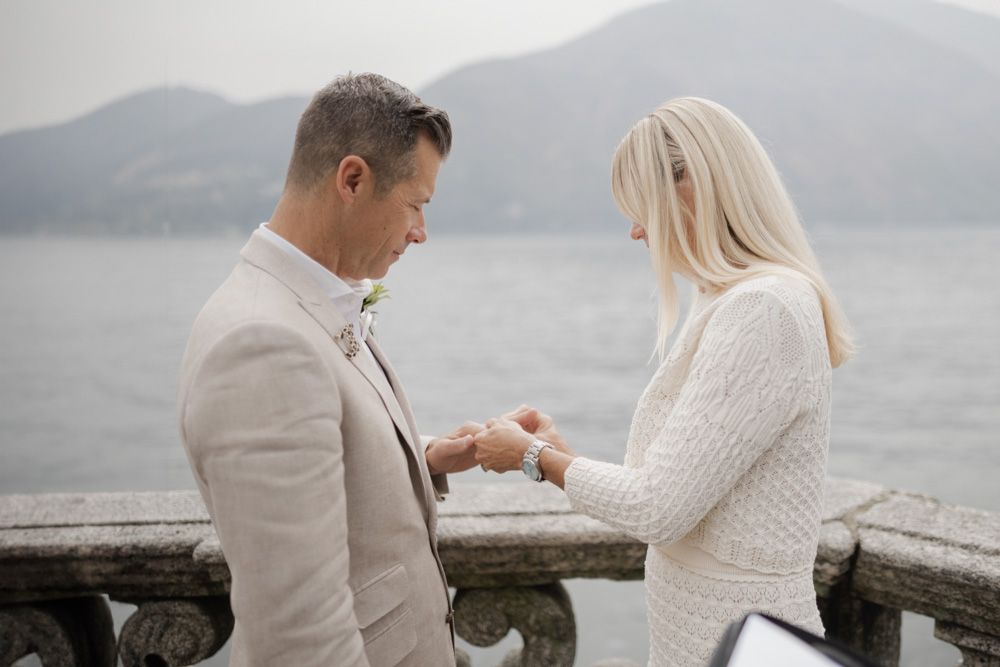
[455,582,576,667]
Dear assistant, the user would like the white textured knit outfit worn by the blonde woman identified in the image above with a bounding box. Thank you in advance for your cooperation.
[566,277,831,667]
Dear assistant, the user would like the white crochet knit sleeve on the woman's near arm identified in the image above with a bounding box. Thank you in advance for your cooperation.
[565,289,807,546]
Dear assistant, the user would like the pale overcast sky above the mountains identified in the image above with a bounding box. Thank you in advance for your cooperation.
[0,0,1000,134]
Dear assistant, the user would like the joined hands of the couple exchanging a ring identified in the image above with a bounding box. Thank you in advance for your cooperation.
[426,405,572,475]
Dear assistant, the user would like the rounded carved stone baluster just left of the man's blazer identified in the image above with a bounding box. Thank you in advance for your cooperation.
[118,596,234,667]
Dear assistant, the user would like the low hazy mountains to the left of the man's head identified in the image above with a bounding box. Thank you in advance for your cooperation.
[0,88,308,233]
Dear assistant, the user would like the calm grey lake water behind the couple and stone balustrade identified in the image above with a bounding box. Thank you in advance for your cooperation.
[0,227,1000,667]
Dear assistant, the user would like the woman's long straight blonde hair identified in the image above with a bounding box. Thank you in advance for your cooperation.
[611,97,854,368]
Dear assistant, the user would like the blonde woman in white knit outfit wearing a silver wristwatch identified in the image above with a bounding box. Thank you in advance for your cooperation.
[476,98,853,666]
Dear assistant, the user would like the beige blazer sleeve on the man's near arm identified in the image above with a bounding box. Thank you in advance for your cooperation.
[181,322,368,667]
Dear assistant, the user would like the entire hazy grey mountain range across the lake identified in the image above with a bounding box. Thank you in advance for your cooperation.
[0,0,1000,233]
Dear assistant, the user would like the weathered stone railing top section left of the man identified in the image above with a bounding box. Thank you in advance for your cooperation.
[0,491,229,602]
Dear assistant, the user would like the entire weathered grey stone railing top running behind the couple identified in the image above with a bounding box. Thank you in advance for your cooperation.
[0,478,1000,632]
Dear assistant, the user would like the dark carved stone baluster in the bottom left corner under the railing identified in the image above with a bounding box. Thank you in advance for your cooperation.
[0,595,115,667]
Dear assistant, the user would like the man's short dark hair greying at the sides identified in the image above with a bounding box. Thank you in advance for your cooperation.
[285,73,451,195]
